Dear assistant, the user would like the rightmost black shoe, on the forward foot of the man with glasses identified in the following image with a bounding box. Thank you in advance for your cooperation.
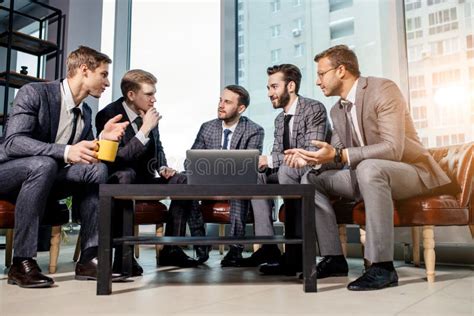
[347,265,398,291]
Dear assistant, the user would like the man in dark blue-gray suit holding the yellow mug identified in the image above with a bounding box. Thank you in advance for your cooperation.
[0,46,128,288]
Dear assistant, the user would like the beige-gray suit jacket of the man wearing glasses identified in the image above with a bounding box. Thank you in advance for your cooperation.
[331,77,450,189]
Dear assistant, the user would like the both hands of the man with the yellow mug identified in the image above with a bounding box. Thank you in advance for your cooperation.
[67,114,129,164]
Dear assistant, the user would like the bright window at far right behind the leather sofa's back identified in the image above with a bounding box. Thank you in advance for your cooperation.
[405,0,474,147]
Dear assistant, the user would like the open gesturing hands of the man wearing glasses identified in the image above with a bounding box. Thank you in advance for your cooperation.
[285,140,336,168]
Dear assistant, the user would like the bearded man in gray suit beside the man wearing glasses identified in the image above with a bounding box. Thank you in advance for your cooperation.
[238,64,330,275]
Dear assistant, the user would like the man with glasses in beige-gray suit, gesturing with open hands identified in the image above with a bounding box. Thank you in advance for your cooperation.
[285,45,449,291]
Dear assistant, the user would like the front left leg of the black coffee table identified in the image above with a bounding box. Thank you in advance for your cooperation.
[97,196,114,295]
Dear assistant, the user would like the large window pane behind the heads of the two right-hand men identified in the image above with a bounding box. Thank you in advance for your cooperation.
[235,0,408,153]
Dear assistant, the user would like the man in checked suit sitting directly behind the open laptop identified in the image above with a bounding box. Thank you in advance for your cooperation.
[189,85,264,267]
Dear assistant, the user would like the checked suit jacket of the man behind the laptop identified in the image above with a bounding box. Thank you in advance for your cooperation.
[191,116,265,153]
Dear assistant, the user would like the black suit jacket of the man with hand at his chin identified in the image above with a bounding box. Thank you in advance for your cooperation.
[95,97,167,177]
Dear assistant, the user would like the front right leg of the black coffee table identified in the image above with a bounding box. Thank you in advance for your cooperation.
[301,194,317,292]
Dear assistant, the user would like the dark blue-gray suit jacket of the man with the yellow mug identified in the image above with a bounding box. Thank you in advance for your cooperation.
[0,80,94,162]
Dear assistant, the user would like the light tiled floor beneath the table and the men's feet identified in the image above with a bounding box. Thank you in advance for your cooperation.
[0,241,474,316]
